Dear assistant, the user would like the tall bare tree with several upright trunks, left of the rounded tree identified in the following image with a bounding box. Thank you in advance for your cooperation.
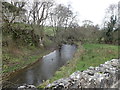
[29,0,53,46]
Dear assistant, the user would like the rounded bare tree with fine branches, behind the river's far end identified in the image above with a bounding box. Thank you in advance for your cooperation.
[49,4,79,46]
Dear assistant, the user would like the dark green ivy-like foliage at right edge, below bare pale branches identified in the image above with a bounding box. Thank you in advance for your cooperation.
[100,16,119,45]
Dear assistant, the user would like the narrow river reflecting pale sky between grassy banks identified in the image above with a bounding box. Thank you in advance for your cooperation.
[3,44,76,87]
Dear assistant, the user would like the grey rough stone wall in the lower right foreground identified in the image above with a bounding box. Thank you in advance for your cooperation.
[45,59,120,89]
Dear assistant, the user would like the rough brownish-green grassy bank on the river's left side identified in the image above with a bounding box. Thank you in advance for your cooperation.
[2,46,51,76]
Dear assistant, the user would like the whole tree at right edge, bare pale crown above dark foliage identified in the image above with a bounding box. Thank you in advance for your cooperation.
[99,4,119,44]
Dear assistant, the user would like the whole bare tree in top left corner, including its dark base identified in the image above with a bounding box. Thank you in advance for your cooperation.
[2,0,26,38]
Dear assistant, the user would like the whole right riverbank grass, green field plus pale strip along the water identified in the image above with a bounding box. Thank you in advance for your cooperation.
[38,44,118,88]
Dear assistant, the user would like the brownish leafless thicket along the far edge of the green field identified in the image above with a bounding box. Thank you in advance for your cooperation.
[56,26,101,44]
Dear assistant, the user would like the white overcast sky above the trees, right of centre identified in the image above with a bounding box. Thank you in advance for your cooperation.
[55,0,120,25]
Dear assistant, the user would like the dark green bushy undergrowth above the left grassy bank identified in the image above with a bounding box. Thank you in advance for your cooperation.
[2,23,39,46]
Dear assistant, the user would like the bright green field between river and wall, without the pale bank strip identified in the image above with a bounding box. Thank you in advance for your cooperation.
[76,44,118,70]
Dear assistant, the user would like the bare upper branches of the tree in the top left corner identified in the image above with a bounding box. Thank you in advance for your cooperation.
[2,0,26,23]
